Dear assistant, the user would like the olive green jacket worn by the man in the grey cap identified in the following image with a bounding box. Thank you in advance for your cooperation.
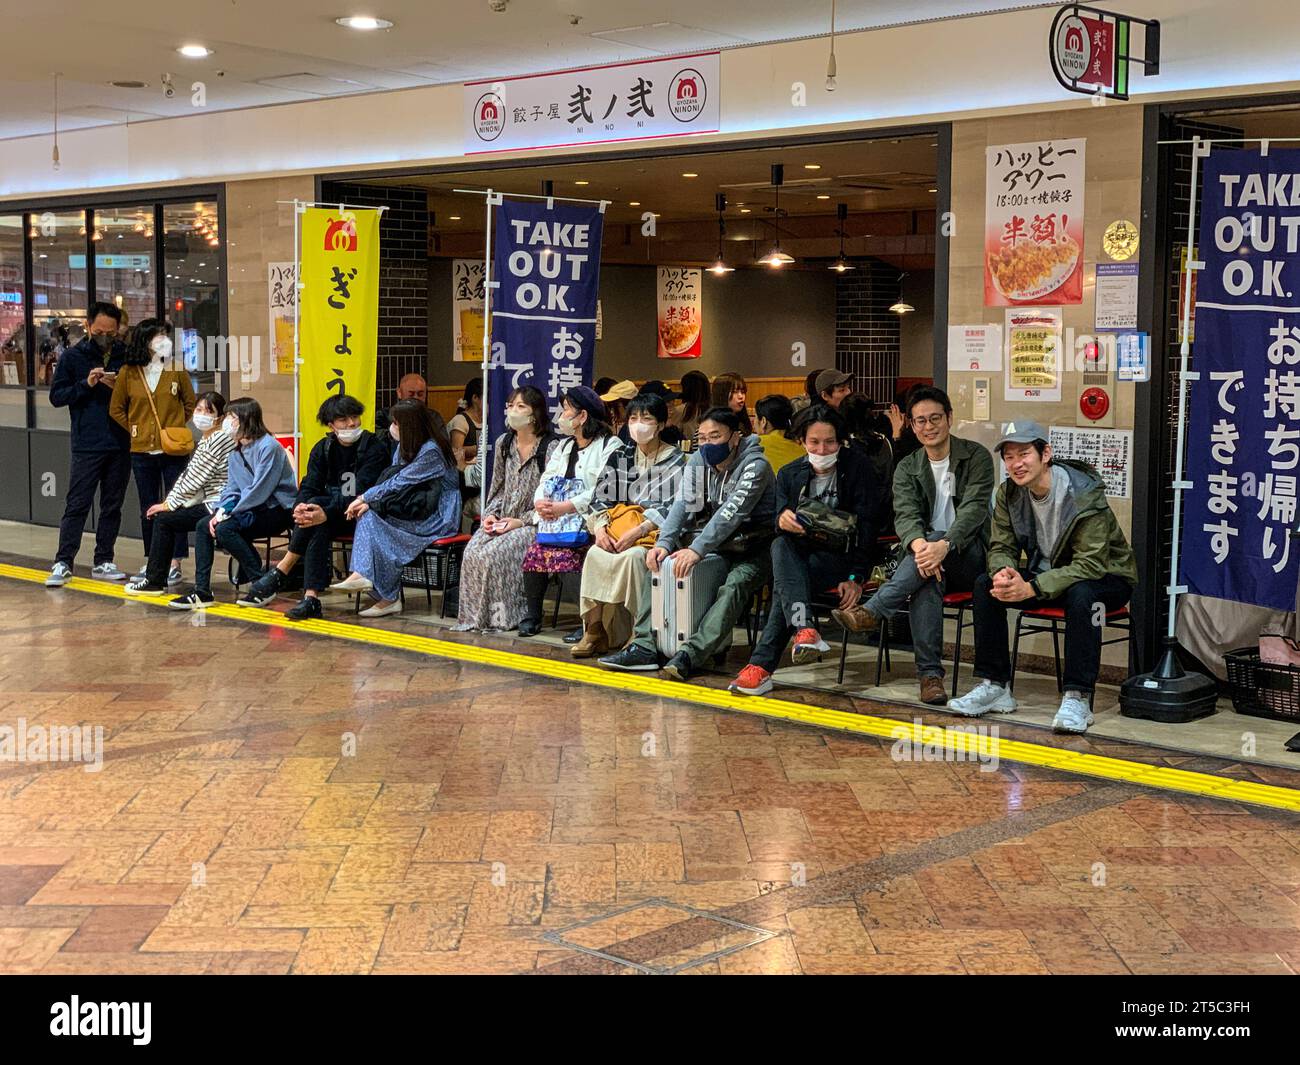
[988,459,1138,599]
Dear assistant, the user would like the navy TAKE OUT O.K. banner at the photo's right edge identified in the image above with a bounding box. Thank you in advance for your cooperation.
[1183,148,1300,610]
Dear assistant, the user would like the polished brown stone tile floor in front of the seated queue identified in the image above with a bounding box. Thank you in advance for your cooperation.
[0,525,1300,974]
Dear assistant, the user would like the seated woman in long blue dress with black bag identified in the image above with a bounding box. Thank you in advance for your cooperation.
[330,399,460,618]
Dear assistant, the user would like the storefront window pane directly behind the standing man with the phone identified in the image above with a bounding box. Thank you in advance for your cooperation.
[27,211,88,388]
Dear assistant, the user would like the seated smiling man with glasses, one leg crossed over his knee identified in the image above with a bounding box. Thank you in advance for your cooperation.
[832,386,993,706]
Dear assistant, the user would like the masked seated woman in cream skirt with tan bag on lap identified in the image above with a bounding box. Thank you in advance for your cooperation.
[572,394,686,658]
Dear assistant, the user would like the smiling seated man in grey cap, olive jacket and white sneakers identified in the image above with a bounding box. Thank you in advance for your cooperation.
[948,421,1138,732]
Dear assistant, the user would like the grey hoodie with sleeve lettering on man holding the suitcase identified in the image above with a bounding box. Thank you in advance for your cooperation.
[655,433,776,557]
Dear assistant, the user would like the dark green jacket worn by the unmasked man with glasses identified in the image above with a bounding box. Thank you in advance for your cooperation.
[894,437,993,551]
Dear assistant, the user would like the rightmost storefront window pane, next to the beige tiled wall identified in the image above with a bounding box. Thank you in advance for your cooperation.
[163,200,219,389]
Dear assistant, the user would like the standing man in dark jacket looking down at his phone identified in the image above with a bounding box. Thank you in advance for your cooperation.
[46,303,131,588]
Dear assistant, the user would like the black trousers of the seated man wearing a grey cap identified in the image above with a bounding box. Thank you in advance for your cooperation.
[971,570,1134,694]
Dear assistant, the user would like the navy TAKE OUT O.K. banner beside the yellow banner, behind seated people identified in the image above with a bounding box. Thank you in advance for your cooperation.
[486,200,605,476]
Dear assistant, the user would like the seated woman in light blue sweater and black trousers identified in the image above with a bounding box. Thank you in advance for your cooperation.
[168,397,298,610]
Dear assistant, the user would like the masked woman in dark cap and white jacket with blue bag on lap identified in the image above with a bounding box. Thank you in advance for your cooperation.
[519,385,621,636]
